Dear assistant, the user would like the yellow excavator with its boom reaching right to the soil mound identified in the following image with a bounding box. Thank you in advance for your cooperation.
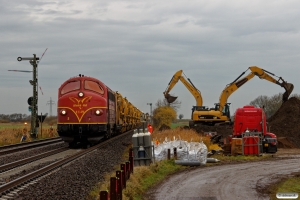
[190,66,294,127]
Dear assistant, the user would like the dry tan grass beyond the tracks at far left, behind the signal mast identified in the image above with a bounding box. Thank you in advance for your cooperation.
[0,122,57,146]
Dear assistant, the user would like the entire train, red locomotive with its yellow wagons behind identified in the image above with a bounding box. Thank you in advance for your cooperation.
[57,74,146,147]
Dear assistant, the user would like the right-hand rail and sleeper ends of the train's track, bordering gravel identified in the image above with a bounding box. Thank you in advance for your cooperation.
[0,132,134,199]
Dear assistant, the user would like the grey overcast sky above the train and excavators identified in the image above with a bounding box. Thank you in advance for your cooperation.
[0,0,300,118]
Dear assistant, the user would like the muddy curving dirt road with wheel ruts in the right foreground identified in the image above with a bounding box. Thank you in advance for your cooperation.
[147,155,300,200]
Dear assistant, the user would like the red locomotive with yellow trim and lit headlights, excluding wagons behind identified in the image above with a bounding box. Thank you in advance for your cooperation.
[57,75,116,143]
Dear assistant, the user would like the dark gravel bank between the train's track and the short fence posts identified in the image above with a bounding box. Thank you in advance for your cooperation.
[14,134,132,200]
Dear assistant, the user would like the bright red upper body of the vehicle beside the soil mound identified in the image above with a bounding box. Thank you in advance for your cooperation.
[233,106,267,137]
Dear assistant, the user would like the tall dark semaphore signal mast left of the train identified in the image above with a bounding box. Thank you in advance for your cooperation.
[17,54,39,138]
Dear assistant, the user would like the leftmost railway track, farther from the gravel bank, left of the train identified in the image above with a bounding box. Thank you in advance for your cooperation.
[0,137,62,156]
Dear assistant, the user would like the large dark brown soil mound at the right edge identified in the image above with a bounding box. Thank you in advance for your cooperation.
[268,97,300,148]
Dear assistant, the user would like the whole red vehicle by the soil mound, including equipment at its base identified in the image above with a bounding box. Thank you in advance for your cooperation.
[211,106,278,155]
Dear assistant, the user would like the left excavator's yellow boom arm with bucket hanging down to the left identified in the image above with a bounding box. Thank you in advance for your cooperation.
[164,70,203,106]
